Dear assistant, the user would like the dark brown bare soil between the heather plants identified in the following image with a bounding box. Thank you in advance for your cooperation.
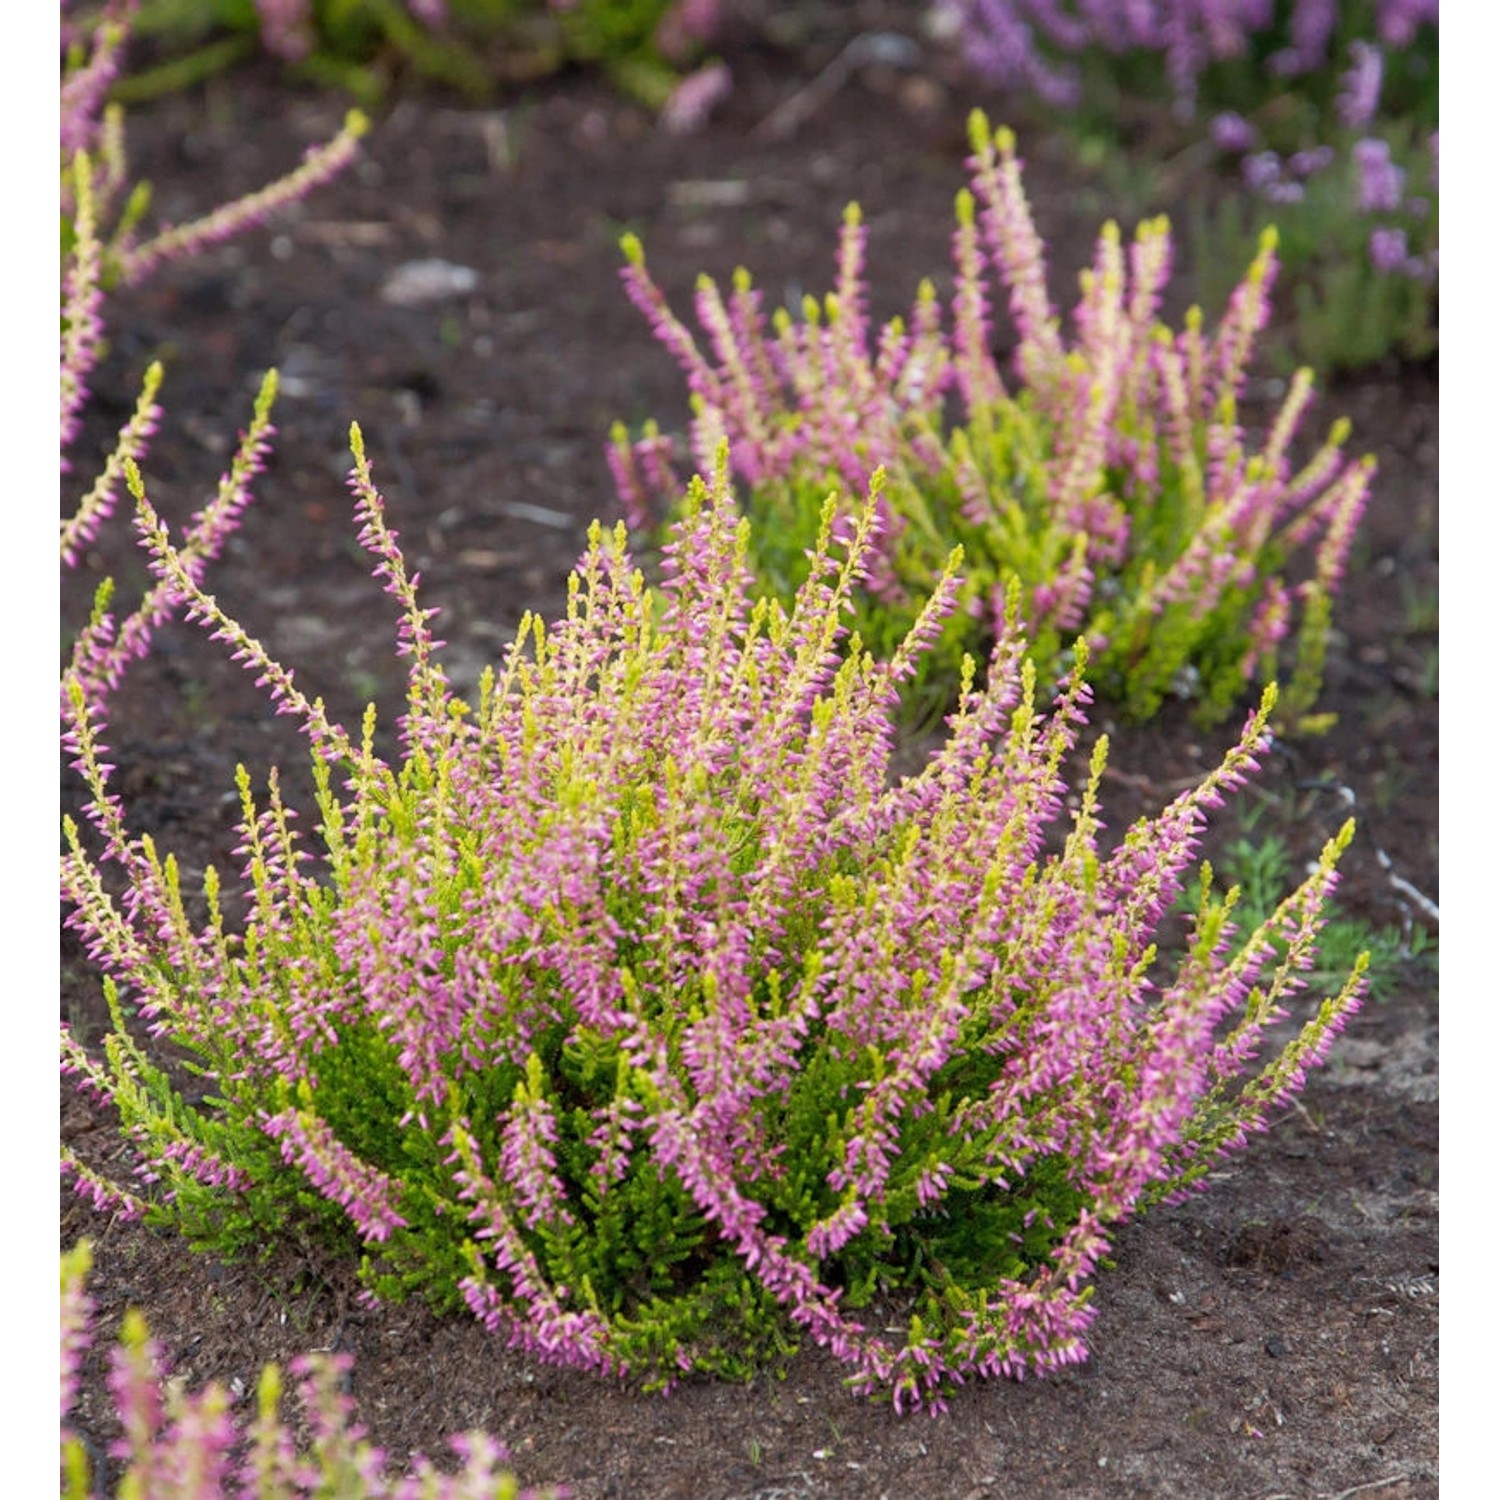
[62,6,1439,1500]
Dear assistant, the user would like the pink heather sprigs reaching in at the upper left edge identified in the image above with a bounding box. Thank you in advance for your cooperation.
[59,0,368,567]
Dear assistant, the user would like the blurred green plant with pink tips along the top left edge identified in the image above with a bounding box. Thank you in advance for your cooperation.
[74,0,723,108]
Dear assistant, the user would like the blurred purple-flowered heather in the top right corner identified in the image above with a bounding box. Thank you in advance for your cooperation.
[935,0,1439,372]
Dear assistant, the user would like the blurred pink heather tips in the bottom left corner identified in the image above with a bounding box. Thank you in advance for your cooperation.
[60,1241,543,1500]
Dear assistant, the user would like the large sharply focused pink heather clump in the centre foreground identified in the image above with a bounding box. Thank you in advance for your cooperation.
[62,428,1364,1407]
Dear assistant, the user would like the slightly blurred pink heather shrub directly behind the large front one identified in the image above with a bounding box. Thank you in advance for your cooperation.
[609,113,1373,723]
